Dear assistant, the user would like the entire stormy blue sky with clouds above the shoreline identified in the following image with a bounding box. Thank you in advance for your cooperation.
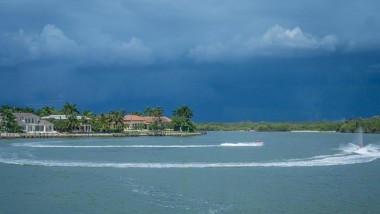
[0,0,380,122]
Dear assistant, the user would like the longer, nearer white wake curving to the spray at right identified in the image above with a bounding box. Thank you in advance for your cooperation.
[0,144,380,169]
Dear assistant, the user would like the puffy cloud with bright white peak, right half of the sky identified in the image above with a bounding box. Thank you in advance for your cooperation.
[189,25,340,62]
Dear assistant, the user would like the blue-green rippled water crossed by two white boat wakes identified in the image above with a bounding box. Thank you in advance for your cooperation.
[0,132,380,213]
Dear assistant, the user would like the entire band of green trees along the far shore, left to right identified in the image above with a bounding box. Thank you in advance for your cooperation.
[0,103,380,133]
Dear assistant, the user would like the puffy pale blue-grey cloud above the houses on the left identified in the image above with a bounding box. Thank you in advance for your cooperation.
[0,24,152,66]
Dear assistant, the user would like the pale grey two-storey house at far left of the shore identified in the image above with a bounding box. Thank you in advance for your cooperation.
[13,113,54,133]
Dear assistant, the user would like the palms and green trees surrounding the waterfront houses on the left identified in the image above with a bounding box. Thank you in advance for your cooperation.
[0,103,196,132]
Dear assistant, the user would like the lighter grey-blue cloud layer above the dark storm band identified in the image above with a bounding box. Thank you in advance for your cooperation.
[0,0,380,66]
